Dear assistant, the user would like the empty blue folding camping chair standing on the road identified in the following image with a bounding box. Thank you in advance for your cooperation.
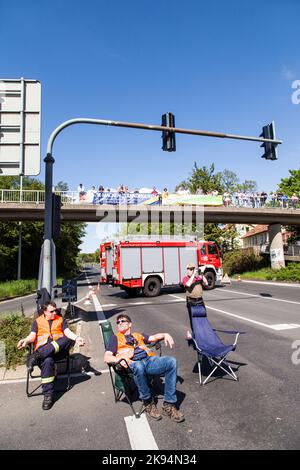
[190,305,244,385]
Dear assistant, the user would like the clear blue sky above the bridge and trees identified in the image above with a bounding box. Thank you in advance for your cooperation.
[0,0,300,251]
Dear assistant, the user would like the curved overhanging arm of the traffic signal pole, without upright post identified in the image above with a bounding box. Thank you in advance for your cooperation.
[47,118,282,154]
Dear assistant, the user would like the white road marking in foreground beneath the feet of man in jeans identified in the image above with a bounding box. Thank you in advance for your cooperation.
[124,413,158,450]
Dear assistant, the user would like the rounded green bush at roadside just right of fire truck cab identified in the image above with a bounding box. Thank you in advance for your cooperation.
[223,250,268,275]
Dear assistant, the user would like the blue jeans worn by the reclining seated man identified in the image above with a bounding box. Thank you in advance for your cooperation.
[130,356,177,403]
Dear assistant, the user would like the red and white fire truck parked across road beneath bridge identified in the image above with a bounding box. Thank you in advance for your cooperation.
[100,240,223,297]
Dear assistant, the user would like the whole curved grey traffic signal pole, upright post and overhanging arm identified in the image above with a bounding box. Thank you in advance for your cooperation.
[42,118,282,296]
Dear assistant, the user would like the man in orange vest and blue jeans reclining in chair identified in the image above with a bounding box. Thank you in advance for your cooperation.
[104,314,184,423]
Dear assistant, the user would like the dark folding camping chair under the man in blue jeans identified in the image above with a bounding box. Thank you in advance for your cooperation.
[101,320,161,418]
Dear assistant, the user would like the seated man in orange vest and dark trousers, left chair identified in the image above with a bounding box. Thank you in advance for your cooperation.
[17,301,85,410]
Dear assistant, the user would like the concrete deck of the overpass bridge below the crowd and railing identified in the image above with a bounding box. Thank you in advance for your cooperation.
[0,202,300,225]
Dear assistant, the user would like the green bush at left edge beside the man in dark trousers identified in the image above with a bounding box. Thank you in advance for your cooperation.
[0,312,32,368]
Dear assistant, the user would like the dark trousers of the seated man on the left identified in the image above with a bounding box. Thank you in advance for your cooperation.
[38,336,74,395]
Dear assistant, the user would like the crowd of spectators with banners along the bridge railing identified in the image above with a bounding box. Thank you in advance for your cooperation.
[77,183,300,209]
